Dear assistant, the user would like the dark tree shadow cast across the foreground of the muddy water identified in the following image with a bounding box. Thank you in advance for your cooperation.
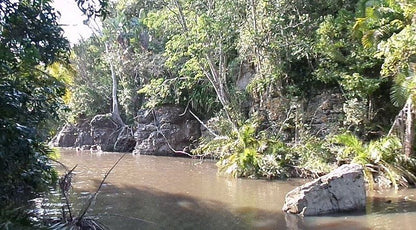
[74,181,369,230]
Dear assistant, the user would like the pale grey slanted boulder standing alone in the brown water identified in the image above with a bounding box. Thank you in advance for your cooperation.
[283,164,366,216]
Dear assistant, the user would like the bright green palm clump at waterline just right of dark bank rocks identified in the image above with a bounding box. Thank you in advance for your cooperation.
[194,117,293,178]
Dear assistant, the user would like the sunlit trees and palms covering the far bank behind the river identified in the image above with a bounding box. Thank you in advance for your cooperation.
[61,0,416,184]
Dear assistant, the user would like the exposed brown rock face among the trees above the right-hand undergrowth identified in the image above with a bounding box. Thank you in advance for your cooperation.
[252,89,345,142]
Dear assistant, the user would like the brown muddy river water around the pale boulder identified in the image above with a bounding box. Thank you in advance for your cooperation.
[39,150,416,230]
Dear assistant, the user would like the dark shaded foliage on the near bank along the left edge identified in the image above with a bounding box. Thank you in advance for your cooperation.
[0,0,69,219]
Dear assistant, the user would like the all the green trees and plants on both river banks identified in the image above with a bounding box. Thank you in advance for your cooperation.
[0,0,416,225]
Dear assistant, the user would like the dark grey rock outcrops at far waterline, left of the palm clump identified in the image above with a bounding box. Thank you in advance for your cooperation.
[51,105,201,155]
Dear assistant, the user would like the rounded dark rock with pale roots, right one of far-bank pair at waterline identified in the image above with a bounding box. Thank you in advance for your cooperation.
[133,105,201,156]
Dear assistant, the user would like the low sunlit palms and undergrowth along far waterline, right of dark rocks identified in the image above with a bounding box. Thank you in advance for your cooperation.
[193,115,416,189]
